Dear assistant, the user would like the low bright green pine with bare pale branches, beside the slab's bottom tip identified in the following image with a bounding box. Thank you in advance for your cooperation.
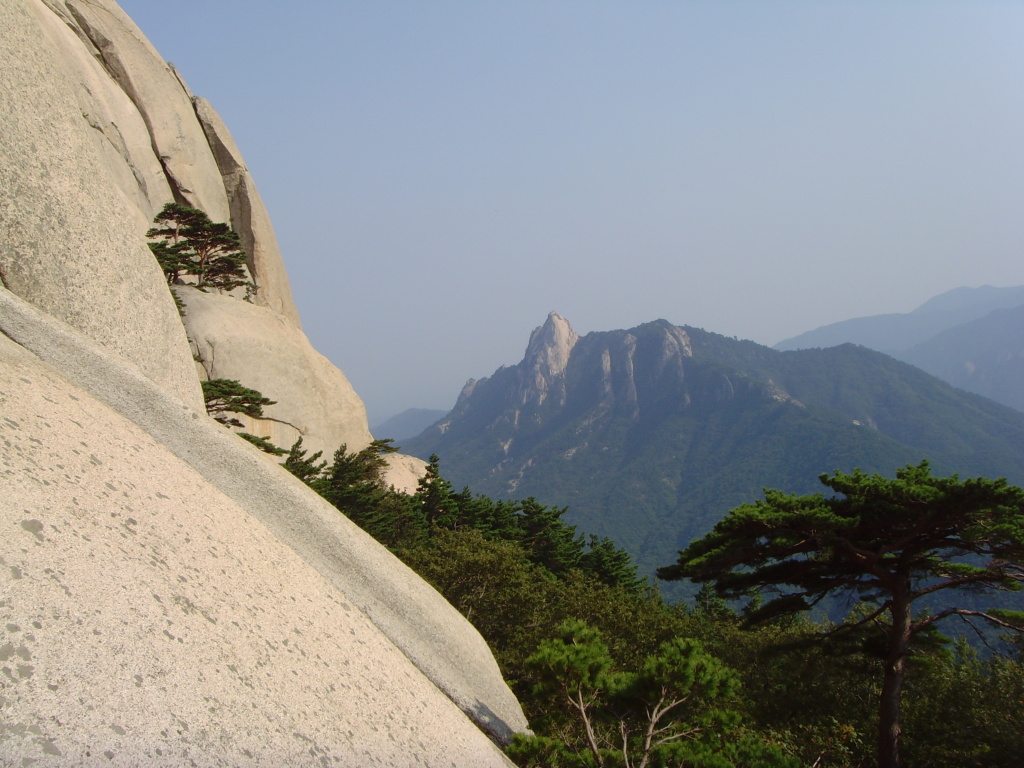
[509,620,798,768]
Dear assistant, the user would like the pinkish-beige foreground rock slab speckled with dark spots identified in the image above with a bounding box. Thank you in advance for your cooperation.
[0,329,511,768]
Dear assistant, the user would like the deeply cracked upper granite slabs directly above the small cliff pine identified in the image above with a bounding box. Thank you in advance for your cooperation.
[40,0,299,326]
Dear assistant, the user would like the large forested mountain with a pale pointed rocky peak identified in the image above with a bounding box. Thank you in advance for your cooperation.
[402,312,1024,572]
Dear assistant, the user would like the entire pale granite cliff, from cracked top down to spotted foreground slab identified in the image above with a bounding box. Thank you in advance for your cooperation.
[0,0,525,766]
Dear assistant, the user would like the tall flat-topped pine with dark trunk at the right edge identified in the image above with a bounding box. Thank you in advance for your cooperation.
[658,462,1024,768]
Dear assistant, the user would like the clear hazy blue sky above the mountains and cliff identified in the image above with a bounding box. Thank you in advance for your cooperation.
[121,0,1024,423]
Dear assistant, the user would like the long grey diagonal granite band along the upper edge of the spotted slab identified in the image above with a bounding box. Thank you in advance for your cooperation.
[0,290,527,741]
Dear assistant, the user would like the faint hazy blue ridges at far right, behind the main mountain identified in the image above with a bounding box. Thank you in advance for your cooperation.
[775,286,1024,411]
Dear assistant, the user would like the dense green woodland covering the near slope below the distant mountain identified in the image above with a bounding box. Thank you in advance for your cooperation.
[285,441,1024,768]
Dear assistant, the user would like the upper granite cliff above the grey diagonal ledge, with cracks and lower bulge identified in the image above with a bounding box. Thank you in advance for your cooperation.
[0,0,373,455]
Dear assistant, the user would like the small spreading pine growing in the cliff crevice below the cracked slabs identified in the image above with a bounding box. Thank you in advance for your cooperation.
[145,203,255,297]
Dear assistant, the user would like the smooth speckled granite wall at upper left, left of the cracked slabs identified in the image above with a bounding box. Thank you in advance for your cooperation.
[0,0,202,415]
